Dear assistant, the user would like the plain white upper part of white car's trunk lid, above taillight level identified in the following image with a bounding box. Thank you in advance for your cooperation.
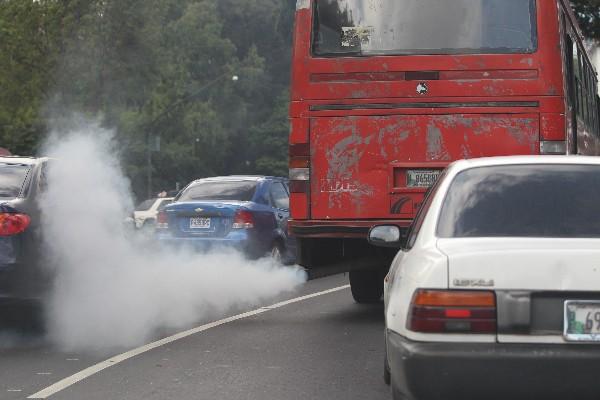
[437,238,600,292]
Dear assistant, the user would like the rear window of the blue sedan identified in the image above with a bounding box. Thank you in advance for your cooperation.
[177,181,258,201]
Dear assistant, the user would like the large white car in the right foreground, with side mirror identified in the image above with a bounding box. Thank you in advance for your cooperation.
[369,156,600,400]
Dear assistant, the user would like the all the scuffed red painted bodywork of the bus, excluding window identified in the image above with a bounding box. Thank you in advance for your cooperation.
[290,0,600,237]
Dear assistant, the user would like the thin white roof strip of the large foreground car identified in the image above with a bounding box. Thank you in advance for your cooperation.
[451,155,600,171]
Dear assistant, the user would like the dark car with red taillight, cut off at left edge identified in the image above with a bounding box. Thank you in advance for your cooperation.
[0,157,49,305]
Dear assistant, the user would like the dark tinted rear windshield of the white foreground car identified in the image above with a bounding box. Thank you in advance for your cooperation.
[437,165,600,238]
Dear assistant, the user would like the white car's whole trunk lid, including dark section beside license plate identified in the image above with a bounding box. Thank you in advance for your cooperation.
[437,238,600,343]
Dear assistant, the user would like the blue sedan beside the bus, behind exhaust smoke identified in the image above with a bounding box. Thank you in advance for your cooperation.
[156,176,296,264]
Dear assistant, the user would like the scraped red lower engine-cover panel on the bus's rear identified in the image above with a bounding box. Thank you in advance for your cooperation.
[310,113,539,219]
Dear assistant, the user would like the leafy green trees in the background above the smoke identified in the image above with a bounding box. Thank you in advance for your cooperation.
[0,0,600,200]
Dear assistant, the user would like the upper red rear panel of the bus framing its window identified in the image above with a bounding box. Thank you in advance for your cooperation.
[291,0,564,101]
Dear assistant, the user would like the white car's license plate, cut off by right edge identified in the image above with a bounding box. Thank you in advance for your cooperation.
[565,300,600,342]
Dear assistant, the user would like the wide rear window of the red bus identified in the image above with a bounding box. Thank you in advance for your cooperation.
[313,0,537,57]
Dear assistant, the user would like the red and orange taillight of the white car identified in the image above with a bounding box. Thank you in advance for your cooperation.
[408,290,497,334]
